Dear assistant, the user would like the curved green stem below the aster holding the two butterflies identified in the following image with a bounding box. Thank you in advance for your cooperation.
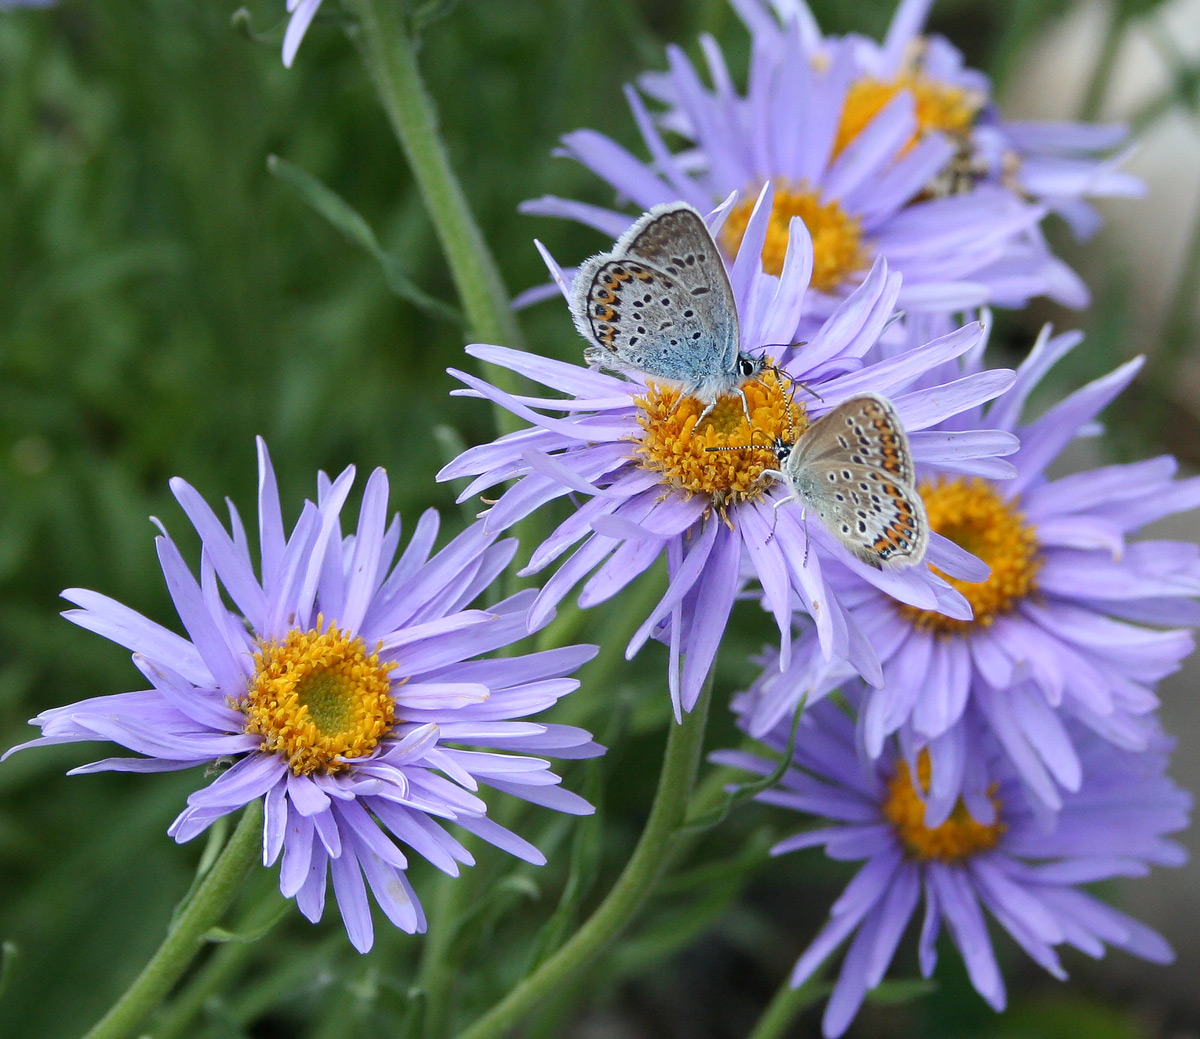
[458,683,710,1039]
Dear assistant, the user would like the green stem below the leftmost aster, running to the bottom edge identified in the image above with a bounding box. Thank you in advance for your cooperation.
[84,800,263,1039]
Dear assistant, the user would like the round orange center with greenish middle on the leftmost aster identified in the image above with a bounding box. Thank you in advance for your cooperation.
[239,617,396,775]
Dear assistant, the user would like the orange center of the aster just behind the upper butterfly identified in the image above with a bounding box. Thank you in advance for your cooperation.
[721,181,869,293]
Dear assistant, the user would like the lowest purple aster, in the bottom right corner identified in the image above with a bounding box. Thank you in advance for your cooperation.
[714,697,1192,1037]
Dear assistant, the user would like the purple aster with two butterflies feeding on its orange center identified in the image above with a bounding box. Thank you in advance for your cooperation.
[438,200,1015,716]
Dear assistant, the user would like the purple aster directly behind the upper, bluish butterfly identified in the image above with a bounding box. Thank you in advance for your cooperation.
[523,4,1086,314]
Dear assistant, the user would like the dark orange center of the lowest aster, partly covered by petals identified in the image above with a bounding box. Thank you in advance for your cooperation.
[883,750,1007,863]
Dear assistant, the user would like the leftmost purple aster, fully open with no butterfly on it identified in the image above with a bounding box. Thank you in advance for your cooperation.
[8,440,601,951]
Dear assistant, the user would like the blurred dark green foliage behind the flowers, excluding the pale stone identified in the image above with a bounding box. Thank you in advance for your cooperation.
[0,0,1185,1039]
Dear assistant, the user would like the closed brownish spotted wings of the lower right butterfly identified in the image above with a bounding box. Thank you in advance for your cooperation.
[784,394,929,569]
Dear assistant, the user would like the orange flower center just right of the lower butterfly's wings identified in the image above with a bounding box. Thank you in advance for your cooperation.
[899,478,1042,633]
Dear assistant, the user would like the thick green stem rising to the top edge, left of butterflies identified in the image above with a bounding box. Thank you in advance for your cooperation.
[353,0,523,407]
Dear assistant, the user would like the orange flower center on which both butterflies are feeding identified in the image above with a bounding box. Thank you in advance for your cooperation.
[635,359,808,508]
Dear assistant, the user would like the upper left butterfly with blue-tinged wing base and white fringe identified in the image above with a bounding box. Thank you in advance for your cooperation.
[571,202,766,420]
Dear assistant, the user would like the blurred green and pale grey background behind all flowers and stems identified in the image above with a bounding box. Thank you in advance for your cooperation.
[0,0,1200,1039]
